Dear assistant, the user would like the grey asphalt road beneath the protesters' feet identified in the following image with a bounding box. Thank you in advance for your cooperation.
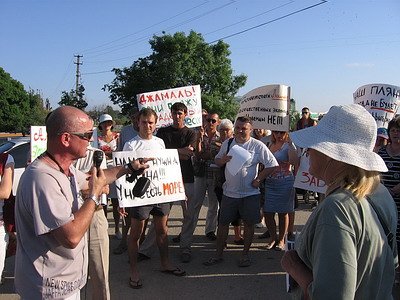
[0,196,400,300]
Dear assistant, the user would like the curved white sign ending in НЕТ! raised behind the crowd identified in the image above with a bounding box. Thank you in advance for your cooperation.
[237,84,290,131]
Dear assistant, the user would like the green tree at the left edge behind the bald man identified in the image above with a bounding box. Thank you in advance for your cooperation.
[0,67,47,133]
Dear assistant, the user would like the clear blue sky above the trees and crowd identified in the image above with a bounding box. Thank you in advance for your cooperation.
[0,0,400,112]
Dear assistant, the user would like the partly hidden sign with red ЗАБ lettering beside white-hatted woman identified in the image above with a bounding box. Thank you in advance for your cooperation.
[293,151,327,194]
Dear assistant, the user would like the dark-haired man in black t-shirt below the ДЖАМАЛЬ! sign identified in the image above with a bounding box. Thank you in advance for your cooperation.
[157,102,196,262]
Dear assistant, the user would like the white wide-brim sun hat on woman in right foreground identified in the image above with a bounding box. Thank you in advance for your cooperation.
[290,104,388,172]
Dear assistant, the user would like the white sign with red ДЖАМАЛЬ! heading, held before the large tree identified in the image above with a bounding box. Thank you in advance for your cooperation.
[137,85,202,127]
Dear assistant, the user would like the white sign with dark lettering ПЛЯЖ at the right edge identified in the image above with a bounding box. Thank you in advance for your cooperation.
[353,83,400,128]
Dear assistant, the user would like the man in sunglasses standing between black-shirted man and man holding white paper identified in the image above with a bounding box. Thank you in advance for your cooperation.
[191,113,221,241]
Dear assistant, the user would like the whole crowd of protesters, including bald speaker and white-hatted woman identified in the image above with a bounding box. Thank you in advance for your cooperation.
[0,102,400,299]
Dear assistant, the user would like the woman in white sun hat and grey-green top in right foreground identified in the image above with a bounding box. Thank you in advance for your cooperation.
[281,104,398,299]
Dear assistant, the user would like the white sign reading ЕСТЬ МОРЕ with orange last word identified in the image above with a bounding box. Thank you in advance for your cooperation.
[113,149,186,207]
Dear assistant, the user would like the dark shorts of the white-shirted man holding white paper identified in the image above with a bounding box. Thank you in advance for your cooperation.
[219,195,260,225]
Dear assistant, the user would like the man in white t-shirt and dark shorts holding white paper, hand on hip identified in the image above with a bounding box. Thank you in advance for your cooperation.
[204,117,278,267]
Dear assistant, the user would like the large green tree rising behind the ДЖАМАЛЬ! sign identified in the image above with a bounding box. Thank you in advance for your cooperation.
[103,31,247,119]
